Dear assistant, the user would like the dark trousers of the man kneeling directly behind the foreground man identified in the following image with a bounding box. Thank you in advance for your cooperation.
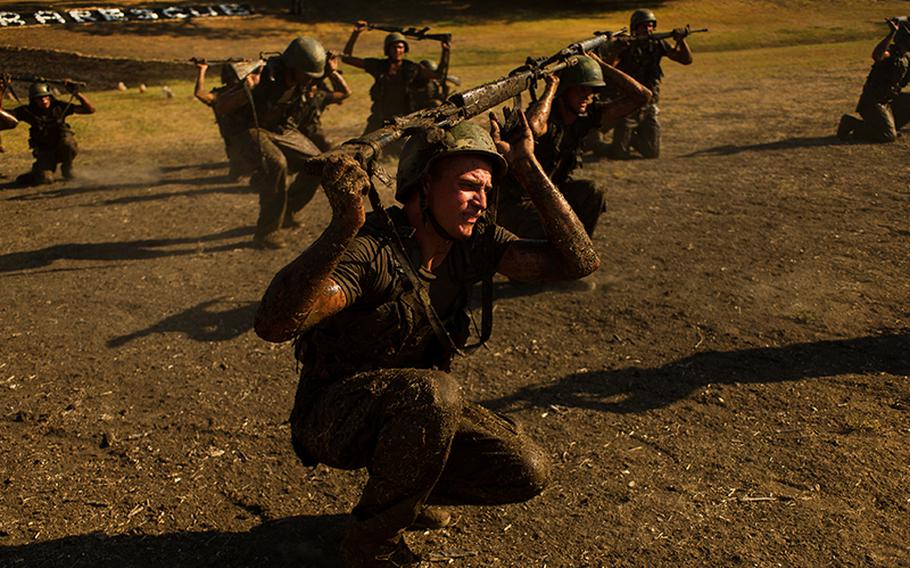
[496,178,607,239]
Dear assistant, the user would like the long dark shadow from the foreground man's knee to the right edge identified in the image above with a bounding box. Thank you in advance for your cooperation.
[484,331,910,413]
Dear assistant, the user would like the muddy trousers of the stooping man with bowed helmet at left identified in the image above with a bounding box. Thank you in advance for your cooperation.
[232,128,320,238]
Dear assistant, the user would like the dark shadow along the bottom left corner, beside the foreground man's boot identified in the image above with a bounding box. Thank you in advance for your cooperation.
[0,515,346,568]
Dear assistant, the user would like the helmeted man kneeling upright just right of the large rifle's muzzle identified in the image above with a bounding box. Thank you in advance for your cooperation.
[604,9,692,160]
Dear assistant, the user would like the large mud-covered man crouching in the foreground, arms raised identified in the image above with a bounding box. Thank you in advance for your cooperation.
[255,106,600,567]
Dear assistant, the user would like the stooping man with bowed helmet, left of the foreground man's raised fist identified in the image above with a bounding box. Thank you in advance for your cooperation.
[213,36,334,249]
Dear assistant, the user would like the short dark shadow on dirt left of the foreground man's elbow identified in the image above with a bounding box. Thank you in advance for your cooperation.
[107,298,258,347]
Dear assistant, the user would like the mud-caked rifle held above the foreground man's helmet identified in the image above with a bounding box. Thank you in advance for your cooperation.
[305,28,614,174]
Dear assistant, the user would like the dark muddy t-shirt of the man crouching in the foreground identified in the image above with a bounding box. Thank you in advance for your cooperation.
[297,207,517,380]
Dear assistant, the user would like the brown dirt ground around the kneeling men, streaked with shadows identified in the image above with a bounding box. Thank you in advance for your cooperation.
[0,6,910,568]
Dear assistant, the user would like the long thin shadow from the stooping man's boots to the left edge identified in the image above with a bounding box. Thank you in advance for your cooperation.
[0,227,253,273]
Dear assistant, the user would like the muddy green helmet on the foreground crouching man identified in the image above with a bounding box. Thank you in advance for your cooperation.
[395,121,508,203]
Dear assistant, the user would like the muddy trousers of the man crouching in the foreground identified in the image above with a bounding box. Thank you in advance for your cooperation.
[291,369,549,556]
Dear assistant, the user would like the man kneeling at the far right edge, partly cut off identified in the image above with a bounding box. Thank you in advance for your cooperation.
[837,18,910,142]
